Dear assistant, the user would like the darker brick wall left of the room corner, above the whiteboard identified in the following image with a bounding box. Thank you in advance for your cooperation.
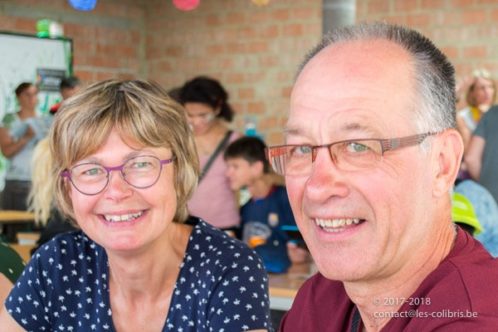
[0,0,146,83]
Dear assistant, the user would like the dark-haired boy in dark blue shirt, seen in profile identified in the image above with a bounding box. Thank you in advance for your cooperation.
[224,137,308,273]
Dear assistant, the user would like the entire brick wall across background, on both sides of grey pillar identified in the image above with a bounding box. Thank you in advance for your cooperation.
[0,0,498,143]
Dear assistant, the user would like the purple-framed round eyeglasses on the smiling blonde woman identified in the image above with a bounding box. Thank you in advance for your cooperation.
[61,156,175,195]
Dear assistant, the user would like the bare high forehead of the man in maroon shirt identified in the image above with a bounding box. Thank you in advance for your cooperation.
[286,40,416,143]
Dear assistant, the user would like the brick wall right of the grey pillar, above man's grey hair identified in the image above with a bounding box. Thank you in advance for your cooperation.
[357,0,498,84]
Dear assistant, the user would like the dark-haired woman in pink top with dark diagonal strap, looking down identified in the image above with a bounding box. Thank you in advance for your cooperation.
[179,76,240,230]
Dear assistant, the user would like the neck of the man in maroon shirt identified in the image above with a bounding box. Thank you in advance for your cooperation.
[344,224,456,331]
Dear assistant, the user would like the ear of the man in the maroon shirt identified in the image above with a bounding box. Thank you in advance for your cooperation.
[432,129,463,197]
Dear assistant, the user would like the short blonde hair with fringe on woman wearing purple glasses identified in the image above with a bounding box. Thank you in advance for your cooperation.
[49,80,199,222]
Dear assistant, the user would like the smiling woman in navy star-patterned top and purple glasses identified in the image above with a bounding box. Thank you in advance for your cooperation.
[0,81,270,331]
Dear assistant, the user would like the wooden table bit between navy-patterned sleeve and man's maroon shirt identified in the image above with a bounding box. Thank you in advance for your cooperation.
[269,263,312,311]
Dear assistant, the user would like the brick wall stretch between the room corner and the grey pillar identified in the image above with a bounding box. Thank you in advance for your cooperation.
[145,0,321,143]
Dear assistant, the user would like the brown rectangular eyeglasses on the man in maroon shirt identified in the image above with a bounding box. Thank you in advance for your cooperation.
[266,132,437,176]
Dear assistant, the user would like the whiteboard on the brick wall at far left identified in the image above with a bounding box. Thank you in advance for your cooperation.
[0,31,72,119]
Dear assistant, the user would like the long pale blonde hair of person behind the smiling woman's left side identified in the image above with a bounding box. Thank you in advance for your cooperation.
[28,138,54,226]
